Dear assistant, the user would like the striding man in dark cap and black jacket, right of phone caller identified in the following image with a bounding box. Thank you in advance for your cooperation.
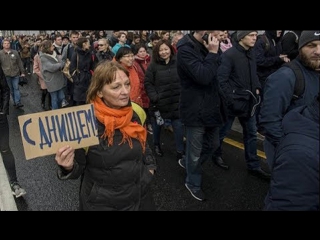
[213,30,270,179]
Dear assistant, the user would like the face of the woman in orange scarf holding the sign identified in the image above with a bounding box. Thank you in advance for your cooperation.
[98,70,131,109]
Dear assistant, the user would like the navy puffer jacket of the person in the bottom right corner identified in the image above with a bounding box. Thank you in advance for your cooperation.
[264,96,319,211]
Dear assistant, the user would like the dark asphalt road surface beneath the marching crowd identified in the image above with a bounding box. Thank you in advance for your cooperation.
[9,74,269,211]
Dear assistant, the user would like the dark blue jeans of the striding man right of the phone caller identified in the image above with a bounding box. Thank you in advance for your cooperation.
[213,116,260,169]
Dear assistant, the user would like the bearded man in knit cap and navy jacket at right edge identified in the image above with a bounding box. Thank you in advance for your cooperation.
[260,30,320,170]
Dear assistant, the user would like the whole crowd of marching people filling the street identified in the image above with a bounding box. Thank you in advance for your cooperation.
[0,30,320,210]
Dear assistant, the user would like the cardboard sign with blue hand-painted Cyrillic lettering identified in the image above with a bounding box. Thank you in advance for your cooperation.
[18,104,99,160]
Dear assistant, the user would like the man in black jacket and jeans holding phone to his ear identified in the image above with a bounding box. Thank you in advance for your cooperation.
[177,30,223,201]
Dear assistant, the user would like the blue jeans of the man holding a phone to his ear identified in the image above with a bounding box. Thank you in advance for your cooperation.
[185,126,219,191]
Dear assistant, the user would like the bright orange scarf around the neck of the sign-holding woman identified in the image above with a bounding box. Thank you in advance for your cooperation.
[92,96,147,152]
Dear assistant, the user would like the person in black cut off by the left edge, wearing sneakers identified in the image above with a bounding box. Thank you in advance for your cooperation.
[0,62,26,198]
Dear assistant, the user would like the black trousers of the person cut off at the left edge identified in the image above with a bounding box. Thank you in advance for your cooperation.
[0,114,17,184]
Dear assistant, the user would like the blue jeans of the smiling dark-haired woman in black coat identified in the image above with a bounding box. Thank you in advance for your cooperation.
[152,118,184,152]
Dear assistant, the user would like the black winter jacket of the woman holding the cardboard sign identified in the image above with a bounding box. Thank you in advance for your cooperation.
[58,106,156,211]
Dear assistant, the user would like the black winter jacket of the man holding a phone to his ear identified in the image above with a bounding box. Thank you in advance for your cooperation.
[177,34,226,127]
